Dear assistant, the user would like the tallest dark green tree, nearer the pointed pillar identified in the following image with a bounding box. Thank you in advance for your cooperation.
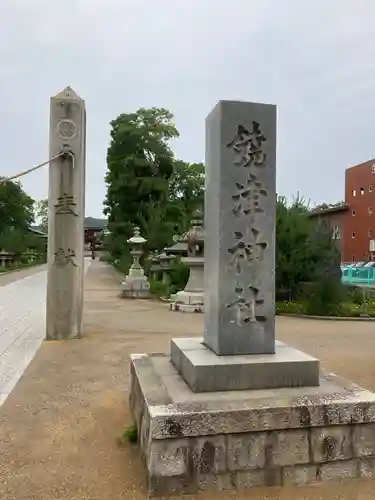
[104,108,179,256]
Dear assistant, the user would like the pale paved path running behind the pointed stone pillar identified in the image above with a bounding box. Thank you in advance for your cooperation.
[0,260,90,406]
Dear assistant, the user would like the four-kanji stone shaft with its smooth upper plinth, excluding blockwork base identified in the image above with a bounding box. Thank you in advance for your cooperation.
[171,101,319,392]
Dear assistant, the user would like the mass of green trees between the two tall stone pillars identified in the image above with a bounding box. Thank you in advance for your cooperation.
[104,108,204,256]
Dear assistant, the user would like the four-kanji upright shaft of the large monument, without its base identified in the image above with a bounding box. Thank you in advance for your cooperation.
[204,101,276,355]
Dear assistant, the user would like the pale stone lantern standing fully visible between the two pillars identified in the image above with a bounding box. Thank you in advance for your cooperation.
[121,227,150,299]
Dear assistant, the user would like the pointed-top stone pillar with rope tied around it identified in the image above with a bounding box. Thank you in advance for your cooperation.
[46,87,86,340]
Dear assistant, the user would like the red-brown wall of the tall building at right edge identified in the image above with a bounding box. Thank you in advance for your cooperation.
[342,160,375,262]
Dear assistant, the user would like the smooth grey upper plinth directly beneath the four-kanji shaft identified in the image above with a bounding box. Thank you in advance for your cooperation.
[171,337,319,392]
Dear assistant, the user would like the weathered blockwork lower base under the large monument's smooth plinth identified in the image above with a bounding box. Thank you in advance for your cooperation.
[130,354,375,497]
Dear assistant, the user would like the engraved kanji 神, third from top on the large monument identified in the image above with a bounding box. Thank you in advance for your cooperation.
[228,228,268,274]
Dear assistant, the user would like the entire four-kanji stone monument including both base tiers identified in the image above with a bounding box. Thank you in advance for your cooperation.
[130,101,375,496]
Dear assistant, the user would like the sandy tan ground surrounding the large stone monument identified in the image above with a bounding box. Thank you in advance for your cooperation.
[0,261,375,500]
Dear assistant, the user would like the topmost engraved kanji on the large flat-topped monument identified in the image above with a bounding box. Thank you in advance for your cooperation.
[227,121,266,167]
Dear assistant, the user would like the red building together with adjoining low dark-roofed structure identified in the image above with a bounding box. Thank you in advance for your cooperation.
[311,160,375,262]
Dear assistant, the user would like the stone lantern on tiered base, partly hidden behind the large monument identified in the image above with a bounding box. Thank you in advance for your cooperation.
[170,210,204,312]
